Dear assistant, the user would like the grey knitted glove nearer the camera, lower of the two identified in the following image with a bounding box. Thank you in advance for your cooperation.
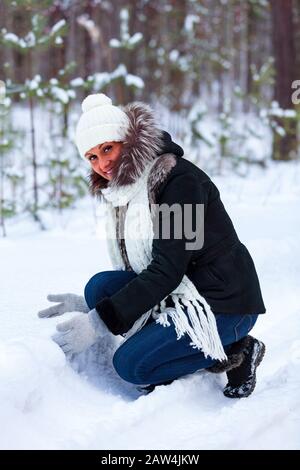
[52,308,109,354]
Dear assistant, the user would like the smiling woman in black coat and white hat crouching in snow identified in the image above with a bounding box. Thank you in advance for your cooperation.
[39,94,266,398]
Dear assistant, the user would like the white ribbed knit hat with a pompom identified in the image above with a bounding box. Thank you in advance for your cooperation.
[75,93,129,158]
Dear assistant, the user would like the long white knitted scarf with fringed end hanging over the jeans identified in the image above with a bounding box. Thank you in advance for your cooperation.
[102,160,227,360]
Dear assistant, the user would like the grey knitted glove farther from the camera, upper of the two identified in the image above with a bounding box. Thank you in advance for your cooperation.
[38,294,90,318]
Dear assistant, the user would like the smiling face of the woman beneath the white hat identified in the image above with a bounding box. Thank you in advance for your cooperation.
[84,141,123,180]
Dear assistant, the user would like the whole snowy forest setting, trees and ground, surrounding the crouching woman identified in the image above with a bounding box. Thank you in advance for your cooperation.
[0,0,300,450]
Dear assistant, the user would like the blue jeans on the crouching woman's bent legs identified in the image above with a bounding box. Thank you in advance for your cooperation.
[84,271,258,385]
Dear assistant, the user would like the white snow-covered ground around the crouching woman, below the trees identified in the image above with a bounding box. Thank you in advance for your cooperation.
[0,163,300,449]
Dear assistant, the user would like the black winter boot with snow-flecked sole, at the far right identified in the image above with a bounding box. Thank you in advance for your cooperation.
[223,335,266,398]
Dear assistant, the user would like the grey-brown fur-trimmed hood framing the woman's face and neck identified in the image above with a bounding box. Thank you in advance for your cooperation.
[89,101,183,198]
